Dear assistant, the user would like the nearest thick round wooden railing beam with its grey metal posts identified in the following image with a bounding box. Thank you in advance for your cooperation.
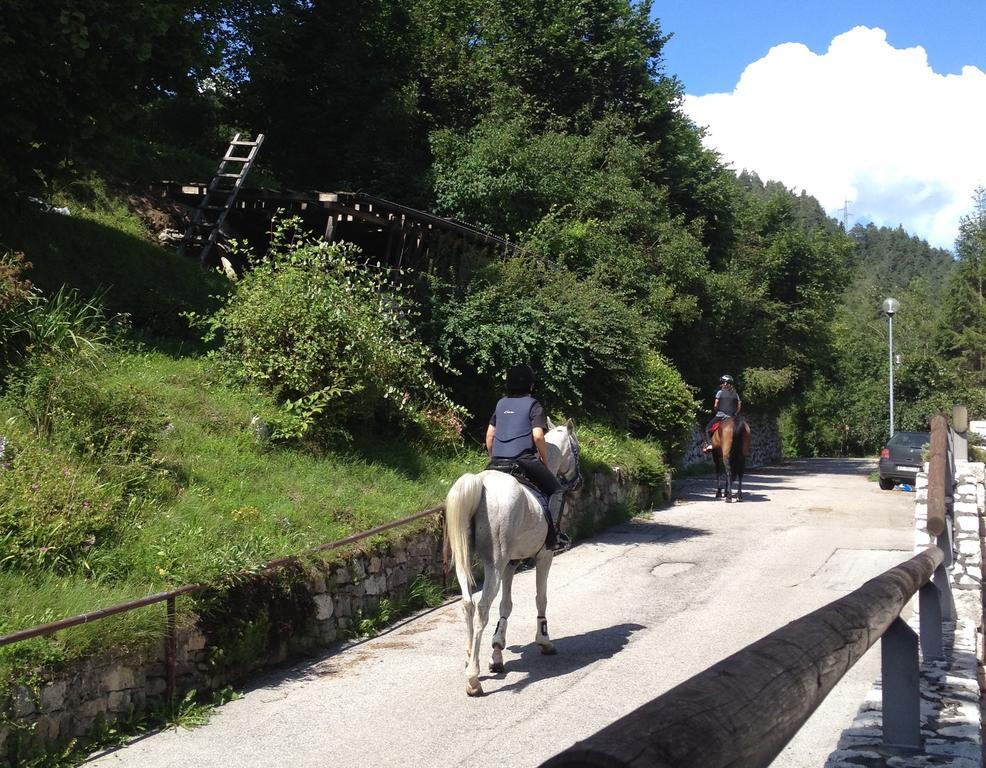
[542,547,943,768]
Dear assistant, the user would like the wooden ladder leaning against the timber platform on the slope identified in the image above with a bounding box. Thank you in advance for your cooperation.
[178,133,264,264]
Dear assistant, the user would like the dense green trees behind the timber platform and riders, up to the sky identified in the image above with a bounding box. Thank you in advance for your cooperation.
[0,0,982,453]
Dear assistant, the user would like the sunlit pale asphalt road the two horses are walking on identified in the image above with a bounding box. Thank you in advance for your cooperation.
[88,459,914,768]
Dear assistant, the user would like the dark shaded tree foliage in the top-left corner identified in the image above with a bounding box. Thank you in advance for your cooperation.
[0,0,220,190]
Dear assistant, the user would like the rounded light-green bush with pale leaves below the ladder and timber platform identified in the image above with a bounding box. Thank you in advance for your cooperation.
[193,220,461,440]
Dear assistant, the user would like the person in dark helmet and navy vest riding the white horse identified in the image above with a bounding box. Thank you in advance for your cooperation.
[486,365,571,551]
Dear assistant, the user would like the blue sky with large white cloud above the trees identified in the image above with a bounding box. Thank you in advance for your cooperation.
[652,0,986,248]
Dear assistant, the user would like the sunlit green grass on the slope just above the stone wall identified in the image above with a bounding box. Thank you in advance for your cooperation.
[0,352,484,664]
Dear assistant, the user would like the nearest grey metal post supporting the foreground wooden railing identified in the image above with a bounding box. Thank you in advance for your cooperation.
[880,616,921,749]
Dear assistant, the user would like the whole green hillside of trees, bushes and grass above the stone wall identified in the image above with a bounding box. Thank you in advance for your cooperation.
[0,0,986,740]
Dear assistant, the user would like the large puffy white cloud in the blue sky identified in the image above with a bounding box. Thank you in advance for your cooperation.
[684,27,986,248]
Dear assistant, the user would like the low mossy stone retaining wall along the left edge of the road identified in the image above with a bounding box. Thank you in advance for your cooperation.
[0,468,670,762]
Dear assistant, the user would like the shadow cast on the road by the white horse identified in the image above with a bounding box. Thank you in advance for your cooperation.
[490,624,645,695]
